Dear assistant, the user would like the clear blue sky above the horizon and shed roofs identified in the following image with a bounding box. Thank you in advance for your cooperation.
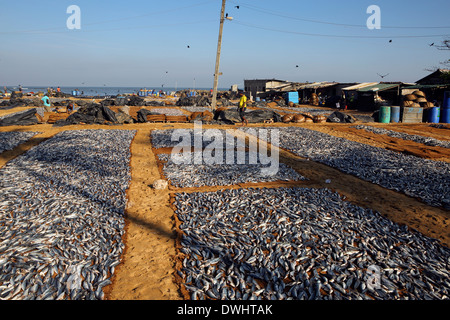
[0,0,450,88]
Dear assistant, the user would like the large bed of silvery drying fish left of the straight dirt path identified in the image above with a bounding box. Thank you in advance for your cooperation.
[0,130,135,300]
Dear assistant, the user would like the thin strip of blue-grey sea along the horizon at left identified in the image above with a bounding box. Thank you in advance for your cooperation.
[6,86,229,97]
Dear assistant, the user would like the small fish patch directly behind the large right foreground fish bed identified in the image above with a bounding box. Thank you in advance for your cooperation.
[159,150,306,188]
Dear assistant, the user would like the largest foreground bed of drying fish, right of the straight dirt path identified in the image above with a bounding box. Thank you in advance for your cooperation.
[175,188,450,300]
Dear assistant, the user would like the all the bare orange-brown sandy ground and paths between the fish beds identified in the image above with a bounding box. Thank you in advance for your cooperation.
[0,107,450,300]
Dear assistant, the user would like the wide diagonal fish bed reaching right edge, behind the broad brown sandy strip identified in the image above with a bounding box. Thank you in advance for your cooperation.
[243,127,450,208]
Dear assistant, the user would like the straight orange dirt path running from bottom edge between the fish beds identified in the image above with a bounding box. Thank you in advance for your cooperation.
[105,129,179,300]
